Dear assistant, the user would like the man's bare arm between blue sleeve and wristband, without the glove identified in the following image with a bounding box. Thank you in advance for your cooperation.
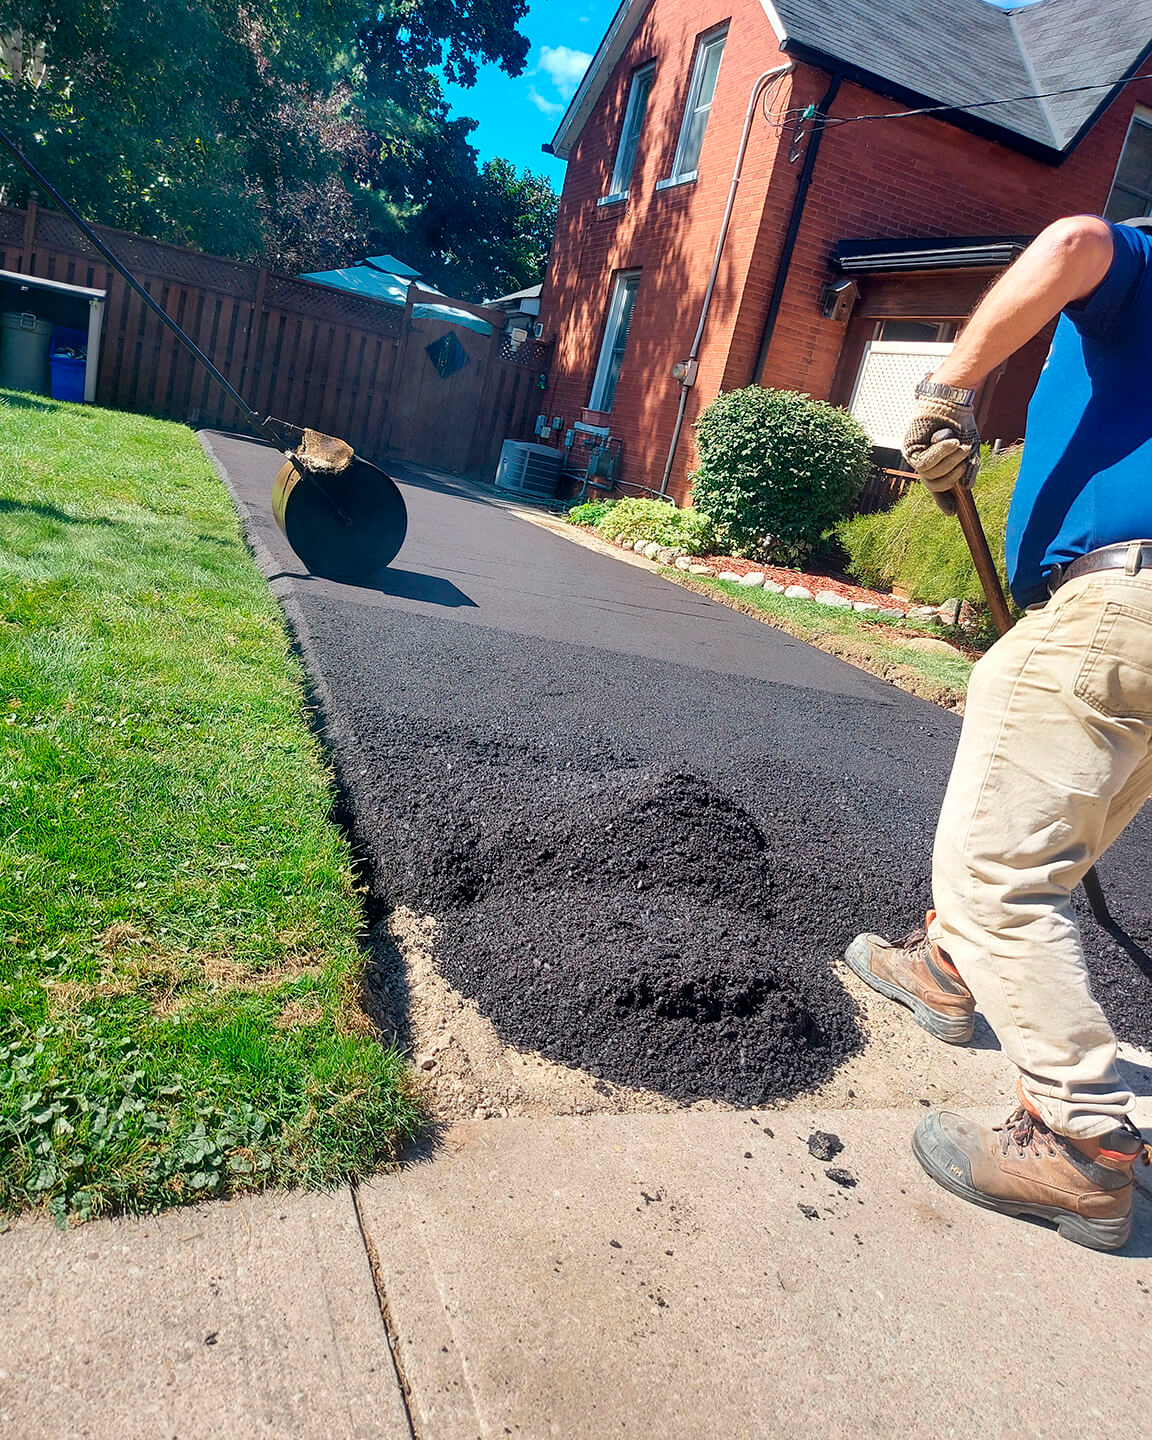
[932,215,1113,390]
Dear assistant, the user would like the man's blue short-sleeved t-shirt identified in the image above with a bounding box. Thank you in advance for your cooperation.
[1005,225,1152,606]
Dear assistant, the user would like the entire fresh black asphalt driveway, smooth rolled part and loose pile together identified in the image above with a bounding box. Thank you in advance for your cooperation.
[203,433,1152,1103]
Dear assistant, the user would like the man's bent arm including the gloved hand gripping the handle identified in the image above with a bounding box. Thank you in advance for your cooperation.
[903,215,1113,514]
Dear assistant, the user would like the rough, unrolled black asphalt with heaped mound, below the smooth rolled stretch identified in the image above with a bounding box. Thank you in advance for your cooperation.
[308,600,1152,1104]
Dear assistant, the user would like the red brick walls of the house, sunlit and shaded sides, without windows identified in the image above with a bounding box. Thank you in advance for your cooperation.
[541,0,1152,501]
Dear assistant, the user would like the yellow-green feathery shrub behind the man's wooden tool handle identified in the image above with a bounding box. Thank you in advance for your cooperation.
[837,448,1021,605]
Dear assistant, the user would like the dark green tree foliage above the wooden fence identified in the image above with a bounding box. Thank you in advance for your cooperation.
[0,0,556,298]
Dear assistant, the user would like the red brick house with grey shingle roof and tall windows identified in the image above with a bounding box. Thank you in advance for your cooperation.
[540,0,1152,503]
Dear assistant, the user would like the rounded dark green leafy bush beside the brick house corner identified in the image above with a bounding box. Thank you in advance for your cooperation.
[693,384,871,564]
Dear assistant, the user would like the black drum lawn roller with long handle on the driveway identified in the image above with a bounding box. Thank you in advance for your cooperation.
[0,131,408,583]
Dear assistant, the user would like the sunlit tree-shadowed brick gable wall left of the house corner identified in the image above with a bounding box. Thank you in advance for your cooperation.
[540,0,786,495]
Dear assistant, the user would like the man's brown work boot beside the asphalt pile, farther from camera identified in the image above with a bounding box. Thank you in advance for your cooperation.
[844,910,976,1045]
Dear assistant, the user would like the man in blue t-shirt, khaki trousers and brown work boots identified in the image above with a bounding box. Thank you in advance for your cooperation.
[847,216,1152,1250]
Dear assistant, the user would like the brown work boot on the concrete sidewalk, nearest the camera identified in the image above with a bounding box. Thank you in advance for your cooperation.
[912,1106,1149,1250]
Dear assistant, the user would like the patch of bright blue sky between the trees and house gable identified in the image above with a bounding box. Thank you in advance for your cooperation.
[445,0,618,182]
